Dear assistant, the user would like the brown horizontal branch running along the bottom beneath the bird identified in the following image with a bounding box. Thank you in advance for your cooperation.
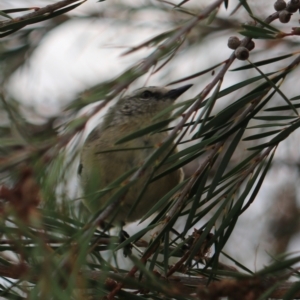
[0,264,300,299]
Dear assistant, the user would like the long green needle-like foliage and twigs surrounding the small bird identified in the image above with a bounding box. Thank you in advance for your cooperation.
[0,0,300,300]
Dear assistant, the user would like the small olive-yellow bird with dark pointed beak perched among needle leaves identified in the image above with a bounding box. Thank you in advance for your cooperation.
[78,84,192,226]
